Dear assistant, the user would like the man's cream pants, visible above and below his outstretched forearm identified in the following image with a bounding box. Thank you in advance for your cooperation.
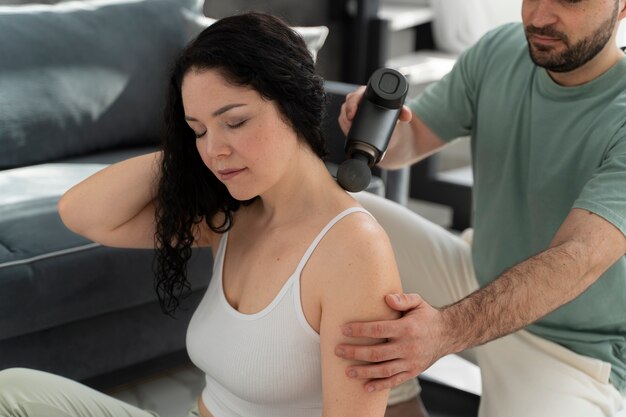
[355,192,624,417]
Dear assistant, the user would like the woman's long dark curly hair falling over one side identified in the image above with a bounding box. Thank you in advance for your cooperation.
[154,13,326,315]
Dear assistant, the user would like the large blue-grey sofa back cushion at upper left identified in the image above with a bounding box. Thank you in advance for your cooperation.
[0,0,188,169]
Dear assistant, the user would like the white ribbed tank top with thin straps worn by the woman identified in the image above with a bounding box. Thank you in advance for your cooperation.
[187,207,367,417]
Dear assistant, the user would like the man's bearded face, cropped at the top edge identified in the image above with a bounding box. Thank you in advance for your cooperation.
[522,0,620,72]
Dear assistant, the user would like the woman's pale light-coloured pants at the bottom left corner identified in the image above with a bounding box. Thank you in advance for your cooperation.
[0,368,200,417]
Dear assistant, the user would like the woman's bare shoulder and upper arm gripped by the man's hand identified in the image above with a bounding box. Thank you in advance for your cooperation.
[302,213,401,417]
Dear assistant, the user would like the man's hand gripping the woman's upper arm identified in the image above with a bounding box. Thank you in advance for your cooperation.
[335,294,450,392]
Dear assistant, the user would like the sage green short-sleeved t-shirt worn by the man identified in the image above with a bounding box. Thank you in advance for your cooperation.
[409,24,626,393]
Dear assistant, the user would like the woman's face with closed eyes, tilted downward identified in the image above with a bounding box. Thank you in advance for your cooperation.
[182,69,300,201]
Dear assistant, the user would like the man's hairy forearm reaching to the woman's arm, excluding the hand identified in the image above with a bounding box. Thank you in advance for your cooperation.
[441,240,601,353]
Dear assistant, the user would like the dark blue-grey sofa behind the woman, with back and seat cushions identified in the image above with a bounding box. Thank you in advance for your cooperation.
[0,0,382,388]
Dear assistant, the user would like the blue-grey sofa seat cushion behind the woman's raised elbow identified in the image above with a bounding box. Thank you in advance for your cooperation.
[0,148,212,341]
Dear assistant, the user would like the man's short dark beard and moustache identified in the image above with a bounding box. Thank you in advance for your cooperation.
[526,7,618,72]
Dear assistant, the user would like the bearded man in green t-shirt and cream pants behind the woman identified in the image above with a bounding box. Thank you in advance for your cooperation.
[336,0,626,417]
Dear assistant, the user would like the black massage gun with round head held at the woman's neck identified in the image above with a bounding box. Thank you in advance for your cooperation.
[337,68,408,192]
